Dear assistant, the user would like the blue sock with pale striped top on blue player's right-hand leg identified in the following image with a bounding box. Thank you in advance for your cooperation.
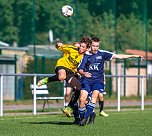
[84,102,96,119]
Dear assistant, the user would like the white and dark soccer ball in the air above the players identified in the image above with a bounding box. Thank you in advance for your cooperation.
[61,5,73,17]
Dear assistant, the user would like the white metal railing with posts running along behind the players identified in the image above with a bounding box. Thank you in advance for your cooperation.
[0,73,152,116]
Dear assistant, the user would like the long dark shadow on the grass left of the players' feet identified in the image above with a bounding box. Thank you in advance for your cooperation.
[21,121,74,125]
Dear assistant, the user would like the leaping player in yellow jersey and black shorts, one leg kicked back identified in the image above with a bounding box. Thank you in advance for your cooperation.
[37,36,92,121]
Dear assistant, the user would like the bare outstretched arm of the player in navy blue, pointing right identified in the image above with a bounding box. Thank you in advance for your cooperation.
[113,54,144,60]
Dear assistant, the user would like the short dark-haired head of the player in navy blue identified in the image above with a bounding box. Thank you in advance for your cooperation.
[90,37,100,53]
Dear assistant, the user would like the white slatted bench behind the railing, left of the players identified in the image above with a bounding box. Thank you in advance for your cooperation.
[30,84,64,111]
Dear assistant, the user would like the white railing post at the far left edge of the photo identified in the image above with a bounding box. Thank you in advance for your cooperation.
[0,74,3,117]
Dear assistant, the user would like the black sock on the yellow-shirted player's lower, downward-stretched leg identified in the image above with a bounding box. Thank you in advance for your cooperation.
[68,90,80,109]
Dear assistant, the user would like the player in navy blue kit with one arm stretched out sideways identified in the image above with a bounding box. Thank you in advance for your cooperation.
[78,37,143,126]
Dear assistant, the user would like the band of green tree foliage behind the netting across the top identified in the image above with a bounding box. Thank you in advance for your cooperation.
[0,0,152,51]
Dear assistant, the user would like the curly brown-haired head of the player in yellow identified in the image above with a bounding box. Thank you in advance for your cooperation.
[79,36,92,54]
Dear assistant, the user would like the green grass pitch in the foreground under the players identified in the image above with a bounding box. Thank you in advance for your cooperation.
[0,110,152,136]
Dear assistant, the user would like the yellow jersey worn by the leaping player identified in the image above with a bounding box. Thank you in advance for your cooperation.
[55,45,83,72]
